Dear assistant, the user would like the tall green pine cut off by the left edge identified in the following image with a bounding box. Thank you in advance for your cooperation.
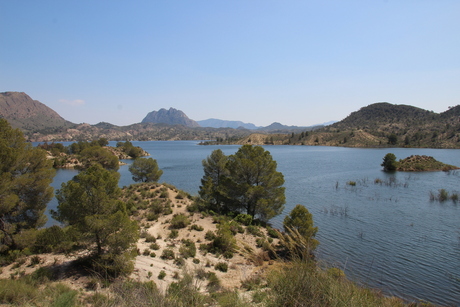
[0,119,55,252]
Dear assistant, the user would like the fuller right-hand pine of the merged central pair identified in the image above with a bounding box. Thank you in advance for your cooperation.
[223,145,286,221]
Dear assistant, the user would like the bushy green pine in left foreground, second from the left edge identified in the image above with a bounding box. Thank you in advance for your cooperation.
[52,164,138,275]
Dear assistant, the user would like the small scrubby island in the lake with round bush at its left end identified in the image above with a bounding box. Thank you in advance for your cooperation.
[381,153,460,172]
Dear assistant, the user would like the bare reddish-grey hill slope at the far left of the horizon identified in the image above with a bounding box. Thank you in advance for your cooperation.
[0,92,74,132]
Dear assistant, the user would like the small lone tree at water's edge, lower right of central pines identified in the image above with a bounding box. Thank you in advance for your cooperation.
[281,205,319,259]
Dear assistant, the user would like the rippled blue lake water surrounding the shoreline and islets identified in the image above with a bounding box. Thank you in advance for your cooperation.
[44,141,460,305]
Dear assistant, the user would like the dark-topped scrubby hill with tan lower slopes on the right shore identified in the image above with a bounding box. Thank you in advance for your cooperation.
[208,102,460,148]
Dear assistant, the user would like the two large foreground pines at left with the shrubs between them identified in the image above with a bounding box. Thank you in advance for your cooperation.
[0,119,138,276]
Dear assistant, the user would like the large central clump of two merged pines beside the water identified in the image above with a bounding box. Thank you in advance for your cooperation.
[199,145,286,221]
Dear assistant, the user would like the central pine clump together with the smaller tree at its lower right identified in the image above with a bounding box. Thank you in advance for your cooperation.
[199,145,318,259]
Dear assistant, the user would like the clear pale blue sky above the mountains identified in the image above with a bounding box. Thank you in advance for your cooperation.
[0,0,460,126]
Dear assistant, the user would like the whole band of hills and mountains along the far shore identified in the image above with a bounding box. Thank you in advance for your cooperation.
[0,92,460,148]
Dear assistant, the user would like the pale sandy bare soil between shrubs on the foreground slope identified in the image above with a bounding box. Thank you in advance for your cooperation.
[0,186,271,291]
